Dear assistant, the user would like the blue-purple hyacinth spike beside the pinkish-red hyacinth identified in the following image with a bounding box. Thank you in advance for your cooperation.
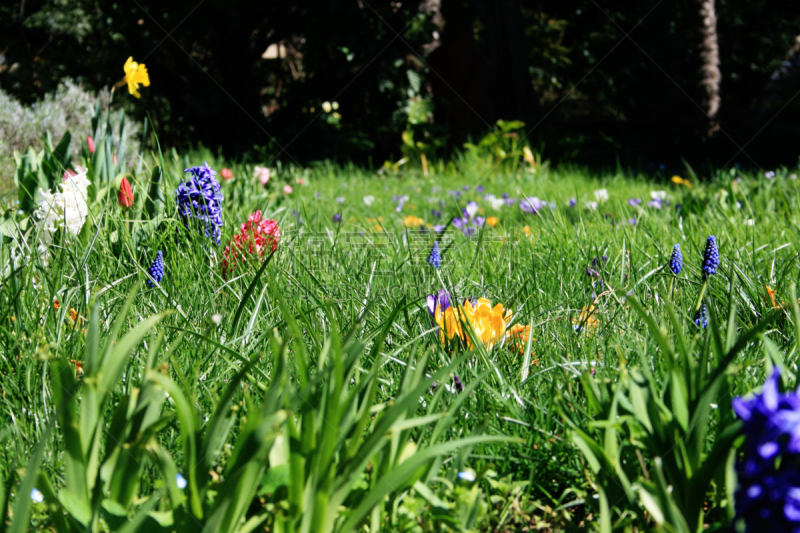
[175,163,223,246]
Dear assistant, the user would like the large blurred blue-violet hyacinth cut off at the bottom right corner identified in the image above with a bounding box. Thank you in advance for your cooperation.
[732,368,800,532]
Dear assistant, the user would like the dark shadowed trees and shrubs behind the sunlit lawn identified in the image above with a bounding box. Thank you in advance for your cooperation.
[0,0,800,168]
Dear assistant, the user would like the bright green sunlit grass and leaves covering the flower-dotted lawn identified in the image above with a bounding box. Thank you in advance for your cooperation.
[0,147,800,531]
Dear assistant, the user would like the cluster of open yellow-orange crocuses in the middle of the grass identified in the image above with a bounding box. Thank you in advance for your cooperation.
[434,298,530,350]
